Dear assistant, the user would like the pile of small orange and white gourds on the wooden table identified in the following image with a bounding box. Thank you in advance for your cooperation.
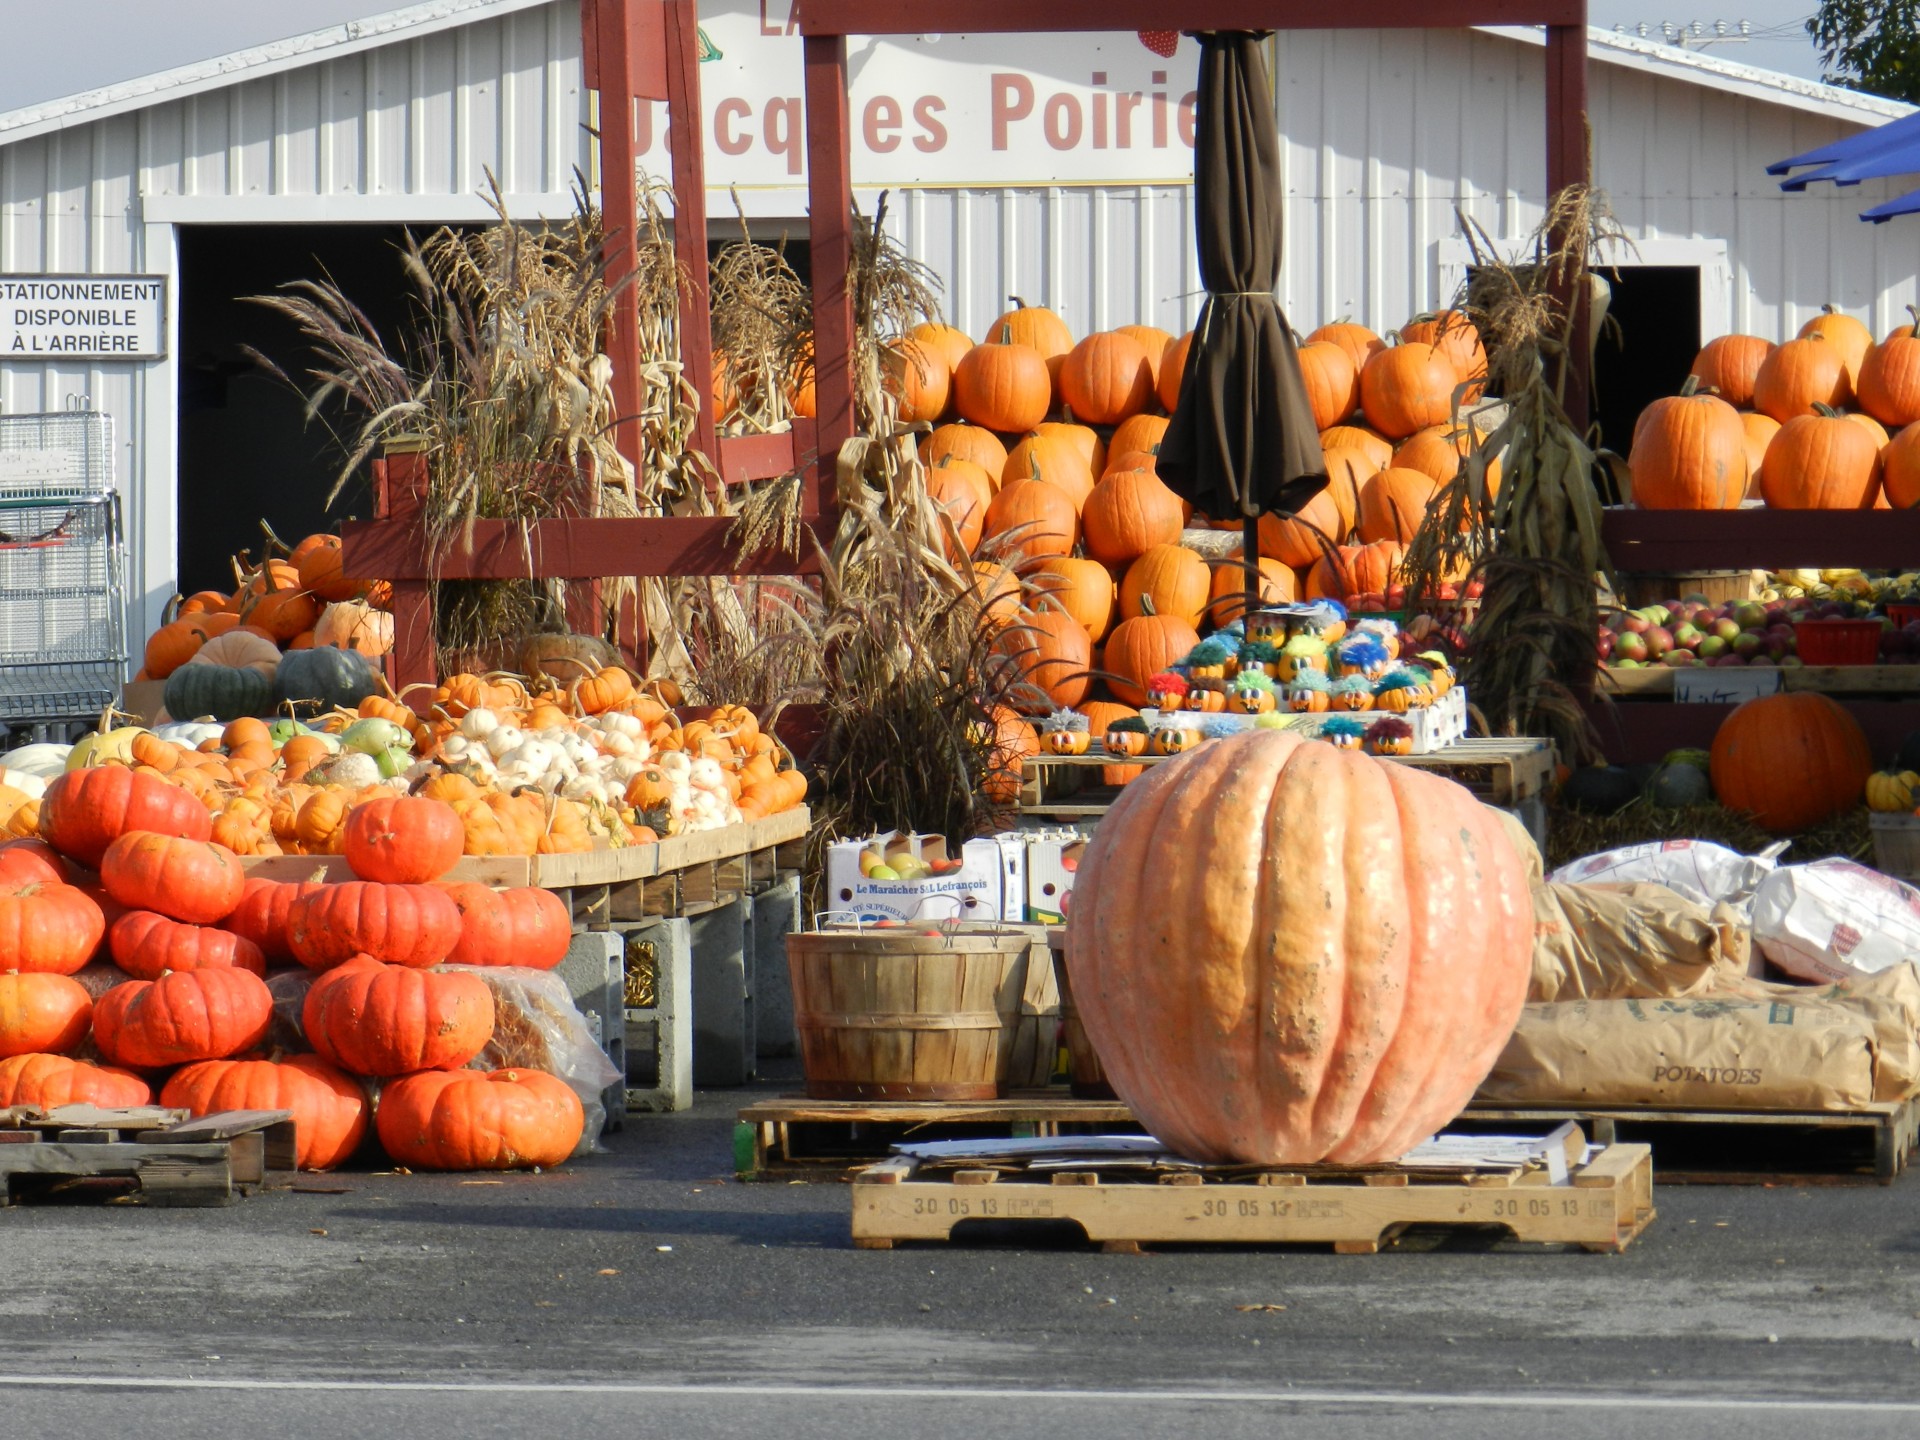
[0,670,806,856]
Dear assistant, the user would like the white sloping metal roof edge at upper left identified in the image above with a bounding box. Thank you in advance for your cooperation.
[0,0,553,146]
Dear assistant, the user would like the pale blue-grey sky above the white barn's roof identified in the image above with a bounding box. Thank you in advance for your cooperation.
[0,0,1820,109]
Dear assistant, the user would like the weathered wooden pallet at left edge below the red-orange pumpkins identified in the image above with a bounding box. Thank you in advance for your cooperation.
[0,1106,294,1206]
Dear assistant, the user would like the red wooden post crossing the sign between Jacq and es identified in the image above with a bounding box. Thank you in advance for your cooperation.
[801,33,852,528]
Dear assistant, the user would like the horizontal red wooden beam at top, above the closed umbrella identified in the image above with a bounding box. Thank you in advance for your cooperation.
[795,0,1586,35]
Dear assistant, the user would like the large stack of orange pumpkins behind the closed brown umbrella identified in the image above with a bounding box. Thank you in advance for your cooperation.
[889,305,1500,748]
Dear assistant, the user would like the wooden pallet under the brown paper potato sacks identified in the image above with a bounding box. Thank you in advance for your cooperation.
[1457,1098,1920,1185]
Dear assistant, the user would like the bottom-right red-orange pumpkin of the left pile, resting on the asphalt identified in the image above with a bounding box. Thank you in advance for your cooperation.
[374,1069,586,1169]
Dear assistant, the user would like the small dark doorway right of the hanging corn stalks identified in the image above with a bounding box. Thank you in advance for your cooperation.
[1594,265,1701,455]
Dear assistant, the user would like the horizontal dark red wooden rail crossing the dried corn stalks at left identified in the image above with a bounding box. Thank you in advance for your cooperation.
[340,515,820,593]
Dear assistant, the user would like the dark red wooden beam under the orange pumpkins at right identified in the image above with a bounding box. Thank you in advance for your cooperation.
[1599,507,1920,570]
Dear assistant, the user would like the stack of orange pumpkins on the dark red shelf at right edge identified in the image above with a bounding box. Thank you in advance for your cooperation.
[1628,305,1920,511]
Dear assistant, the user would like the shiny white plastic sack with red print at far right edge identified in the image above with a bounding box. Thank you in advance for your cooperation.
[1753,860,1920,983]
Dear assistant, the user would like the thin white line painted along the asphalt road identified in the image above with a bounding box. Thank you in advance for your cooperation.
[0,1375,1920,1415]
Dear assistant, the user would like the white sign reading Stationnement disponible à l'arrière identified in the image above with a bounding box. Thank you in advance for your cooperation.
[0,275,167,361]
